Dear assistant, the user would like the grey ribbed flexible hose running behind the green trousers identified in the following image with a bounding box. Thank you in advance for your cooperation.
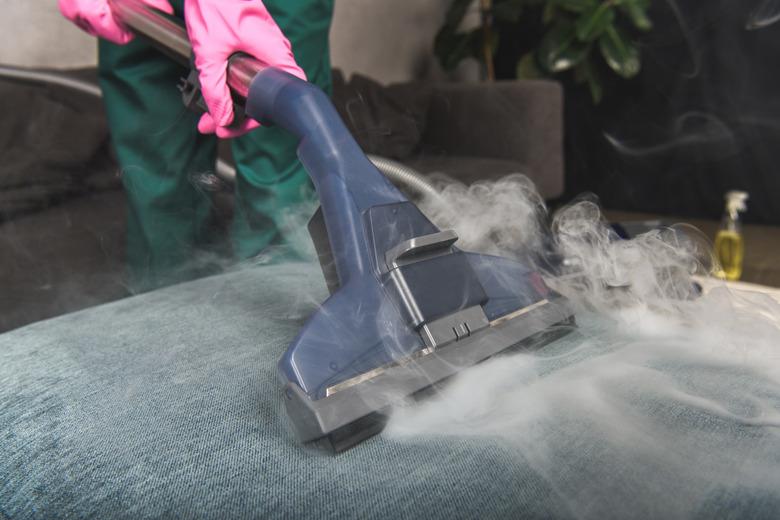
[0,65,439,197]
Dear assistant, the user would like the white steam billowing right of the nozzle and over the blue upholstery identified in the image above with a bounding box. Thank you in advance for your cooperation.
[386,177,780,518]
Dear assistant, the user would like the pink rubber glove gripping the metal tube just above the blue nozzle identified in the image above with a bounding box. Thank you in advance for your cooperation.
[184,0,306,138]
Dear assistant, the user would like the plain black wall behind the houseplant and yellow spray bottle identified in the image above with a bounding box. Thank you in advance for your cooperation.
[497,0,780,224]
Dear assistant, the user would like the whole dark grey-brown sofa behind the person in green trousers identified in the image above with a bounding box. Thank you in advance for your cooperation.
[0,71,563,331]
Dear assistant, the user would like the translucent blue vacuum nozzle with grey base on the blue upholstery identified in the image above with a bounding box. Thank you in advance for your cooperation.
[246,69,572,451]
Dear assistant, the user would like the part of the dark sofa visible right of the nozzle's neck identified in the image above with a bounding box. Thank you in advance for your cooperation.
[334,74,563,200]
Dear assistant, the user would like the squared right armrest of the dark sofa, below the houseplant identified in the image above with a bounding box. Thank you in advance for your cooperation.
[422,80,564,199]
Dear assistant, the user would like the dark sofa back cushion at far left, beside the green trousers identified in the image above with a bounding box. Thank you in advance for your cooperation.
[0,71,120,221]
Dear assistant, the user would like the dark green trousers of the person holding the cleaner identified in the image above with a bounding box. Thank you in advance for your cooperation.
[99,0,333,292]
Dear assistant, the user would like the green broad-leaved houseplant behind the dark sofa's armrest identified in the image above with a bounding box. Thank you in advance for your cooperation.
[434,0,652,103]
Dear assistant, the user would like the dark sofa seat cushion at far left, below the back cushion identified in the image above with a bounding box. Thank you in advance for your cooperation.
[0,190,128,332]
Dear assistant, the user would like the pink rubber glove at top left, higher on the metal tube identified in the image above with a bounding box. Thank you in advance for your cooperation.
[59,0,173,45]
